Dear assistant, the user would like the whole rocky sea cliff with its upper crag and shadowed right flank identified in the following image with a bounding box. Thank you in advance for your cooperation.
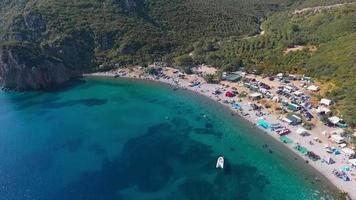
[0,3,95,90]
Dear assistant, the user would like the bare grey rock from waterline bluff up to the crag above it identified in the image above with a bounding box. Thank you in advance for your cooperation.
[0,11,70,90]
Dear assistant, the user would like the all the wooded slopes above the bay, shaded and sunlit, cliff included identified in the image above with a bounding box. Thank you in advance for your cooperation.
[0,0,356,125]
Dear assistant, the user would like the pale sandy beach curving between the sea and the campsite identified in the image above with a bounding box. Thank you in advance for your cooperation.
[85,67,356,200]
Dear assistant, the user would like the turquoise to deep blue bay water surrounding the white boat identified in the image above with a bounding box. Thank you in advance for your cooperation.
[0,78,333,200]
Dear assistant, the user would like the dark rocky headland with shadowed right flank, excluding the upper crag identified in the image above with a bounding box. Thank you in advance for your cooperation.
[0,27,95,90]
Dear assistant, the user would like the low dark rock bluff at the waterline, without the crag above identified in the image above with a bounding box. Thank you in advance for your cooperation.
[0,44,77,90]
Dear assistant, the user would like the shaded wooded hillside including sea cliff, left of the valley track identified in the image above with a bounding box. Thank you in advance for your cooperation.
[0,0,300,89]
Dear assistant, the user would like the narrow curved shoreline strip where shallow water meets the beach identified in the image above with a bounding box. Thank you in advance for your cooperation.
[85,73,344,199]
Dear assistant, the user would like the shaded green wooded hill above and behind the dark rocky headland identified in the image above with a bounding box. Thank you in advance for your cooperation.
[0,0,294,64]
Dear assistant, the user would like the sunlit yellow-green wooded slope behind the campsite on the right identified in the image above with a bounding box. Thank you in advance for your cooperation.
[189,1,356,126]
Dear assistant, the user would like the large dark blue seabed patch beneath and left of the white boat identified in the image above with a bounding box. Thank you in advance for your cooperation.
[50,118,268,200]
